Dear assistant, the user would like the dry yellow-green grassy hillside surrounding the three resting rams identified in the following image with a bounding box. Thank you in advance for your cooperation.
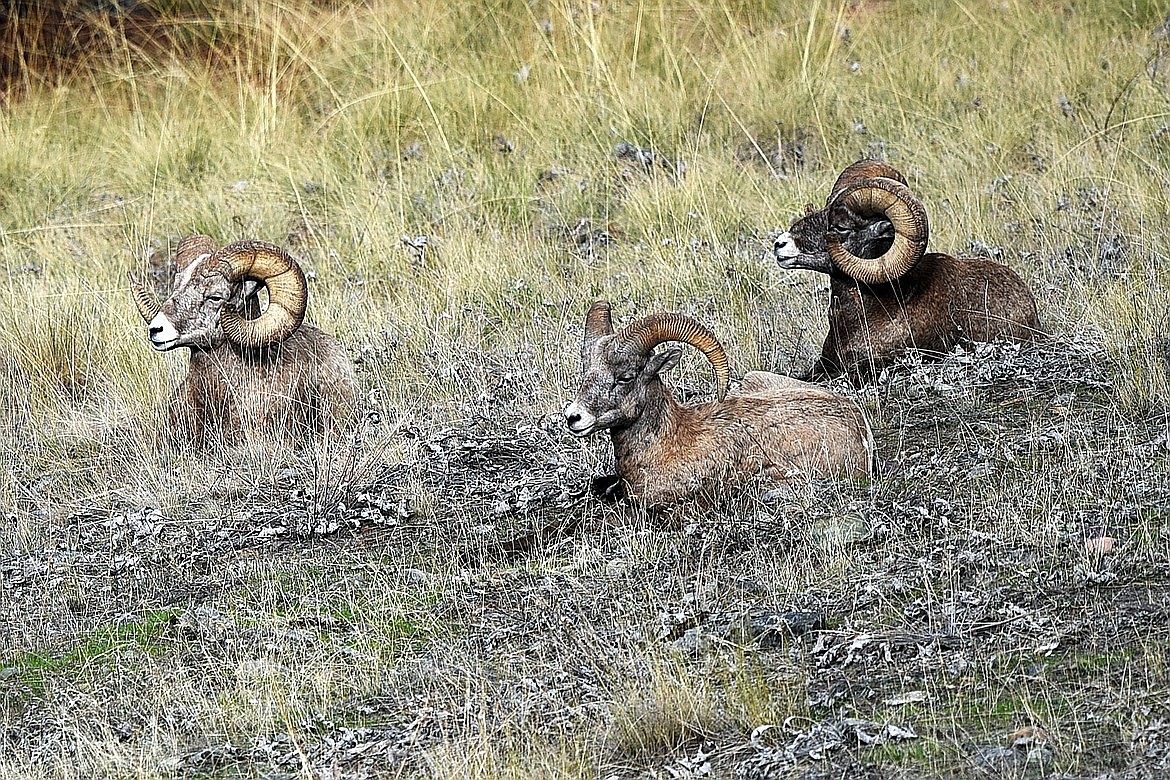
[0,0,1170,780]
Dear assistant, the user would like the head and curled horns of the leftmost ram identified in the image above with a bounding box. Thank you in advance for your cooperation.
[131,235,308,352]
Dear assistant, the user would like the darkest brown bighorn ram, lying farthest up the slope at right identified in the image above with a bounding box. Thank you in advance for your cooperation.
[775,160,1041,384]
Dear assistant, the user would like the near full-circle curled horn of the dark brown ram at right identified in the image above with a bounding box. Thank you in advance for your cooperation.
[825,178,930,284]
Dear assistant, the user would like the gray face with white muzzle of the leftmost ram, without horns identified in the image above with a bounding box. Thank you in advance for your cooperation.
[146,255,250,352]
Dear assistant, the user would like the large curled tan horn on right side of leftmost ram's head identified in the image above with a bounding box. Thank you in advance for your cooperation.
[208,241,309,347]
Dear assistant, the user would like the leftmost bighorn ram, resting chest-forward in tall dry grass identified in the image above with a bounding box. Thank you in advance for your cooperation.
[131,235,357,444]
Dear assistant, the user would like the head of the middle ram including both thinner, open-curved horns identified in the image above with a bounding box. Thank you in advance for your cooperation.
[565,301,730,436]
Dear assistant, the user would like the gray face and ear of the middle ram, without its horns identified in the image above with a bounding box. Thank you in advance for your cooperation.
[565,336,682,436]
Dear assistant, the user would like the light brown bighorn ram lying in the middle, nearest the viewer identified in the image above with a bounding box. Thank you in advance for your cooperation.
[565,301,873,508]
